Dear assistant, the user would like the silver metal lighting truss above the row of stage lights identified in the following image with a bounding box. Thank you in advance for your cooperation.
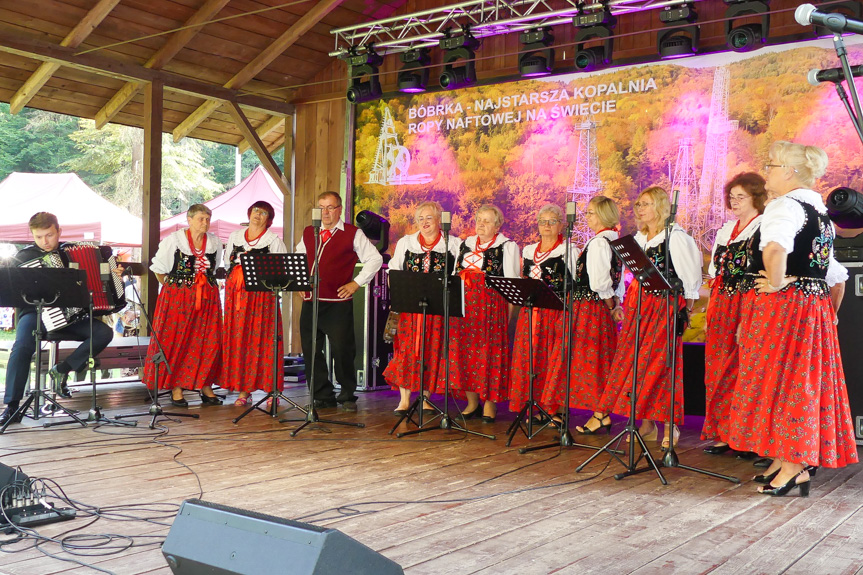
[330,0,701,58]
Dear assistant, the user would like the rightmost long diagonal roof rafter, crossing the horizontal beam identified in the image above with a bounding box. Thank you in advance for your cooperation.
[174,0,342,143]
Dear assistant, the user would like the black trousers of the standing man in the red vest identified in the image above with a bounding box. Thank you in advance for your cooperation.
[300,301,357,403]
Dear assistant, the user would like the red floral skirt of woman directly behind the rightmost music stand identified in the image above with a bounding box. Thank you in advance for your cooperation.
[599,288,684,423]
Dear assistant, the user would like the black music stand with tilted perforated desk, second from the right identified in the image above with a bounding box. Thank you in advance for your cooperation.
[485,276,569,447]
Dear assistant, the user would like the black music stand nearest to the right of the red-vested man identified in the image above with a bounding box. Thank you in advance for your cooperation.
[389,270,462,437]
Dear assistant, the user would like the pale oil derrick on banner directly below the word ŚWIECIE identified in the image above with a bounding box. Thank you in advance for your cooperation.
[566,120,602,248]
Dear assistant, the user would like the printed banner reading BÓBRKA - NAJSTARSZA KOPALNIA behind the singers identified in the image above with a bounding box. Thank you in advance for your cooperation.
[354,36,863,250]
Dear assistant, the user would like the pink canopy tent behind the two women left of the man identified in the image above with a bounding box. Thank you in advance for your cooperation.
[159,166,284,242]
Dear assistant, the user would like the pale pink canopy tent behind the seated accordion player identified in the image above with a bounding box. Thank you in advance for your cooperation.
[0,172,141,247]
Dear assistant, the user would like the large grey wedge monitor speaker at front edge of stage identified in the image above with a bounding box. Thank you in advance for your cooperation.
[162,499,404,575]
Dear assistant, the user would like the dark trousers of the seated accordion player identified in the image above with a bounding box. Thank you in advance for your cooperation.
[3,313,114,404]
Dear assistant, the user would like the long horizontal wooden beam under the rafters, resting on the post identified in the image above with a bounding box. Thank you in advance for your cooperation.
[0,29,294,116]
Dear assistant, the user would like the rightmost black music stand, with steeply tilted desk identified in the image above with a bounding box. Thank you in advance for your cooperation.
[575,235,674,485]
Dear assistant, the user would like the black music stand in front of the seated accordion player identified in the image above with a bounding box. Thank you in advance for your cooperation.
[0,268,90,433]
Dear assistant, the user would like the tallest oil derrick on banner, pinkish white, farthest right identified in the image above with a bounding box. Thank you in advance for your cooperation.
[689,66,737,250]
